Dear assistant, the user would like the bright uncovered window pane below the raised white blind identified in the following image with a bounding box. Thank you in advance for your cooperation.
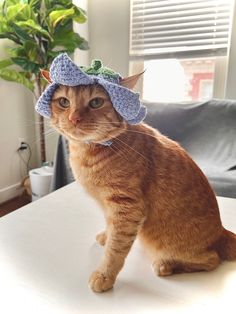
[140,58,216,102]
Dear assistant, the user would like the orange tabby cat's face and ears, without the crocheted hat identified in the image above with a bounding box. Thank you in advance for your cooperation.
[48,73,143,143]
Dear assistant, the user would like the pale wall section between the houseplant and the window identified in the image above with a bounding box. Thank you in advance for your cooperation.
[88,0,130,76]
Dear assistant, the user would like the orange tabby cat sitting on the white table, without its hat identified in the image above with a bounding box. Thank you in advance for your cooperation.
[48,76,236,292]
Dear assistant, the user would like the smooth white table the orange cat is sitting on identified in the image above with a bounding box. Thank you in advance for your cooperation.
[0,183,236,314]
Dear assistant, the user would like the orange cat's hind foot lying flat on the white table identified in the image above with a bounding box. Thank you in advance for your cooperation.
[152,251,220,276]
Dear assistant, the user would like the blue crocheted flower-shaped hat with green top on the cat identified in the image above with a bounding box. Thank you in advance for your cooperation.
[35,53,147,124]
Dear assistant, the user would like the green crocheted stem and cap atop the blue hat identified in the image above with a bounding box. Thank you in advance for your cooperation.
[80,59,120,79]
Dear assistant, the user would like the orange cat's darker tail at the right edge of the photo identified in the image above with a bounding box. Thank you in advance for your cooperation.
[215,229,236,261]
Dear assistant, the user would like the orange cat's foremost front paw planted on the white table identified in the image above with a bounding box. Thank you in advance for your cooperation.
[89,271,115,292]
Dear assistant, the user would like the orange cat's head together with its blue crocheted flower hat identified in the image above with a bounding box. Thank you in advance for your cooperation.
[36,53,146,143]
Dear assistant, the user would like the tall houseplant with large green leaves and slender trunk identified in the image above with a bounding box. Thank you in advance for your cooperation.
[0,0,88,162]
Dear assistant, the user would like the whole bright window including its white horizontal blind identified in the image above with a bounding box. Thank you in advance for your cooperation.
[130,0,233,102]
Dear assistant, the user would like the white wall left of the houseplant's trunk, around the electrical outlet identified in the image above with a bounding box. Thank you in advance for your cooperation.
[0,40,36,203]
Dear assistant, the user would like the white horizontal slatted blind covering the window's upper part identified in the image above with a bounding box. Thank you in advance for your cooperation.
[130,0,233,57]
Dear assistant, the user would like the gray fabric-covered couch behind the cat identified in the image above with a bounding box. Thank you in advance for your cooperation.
[52,100,236,198]
